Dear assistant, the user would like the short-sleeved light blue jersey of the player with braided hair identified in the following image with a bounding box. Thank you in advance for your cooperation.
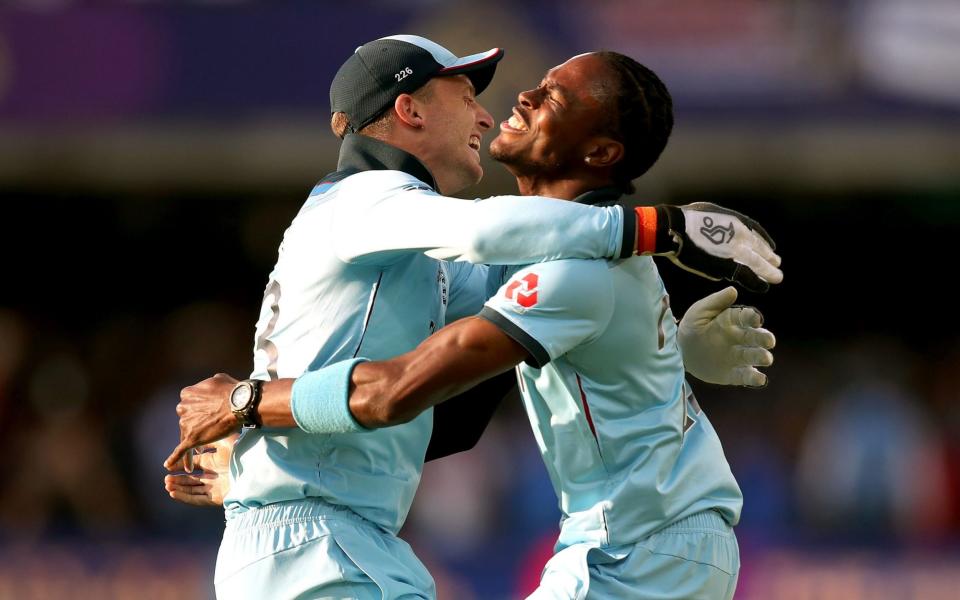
[481,190,743,550]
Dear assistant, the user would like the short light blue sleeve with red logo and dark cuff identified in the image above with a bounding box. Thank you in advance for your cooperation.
[480,260,613,368]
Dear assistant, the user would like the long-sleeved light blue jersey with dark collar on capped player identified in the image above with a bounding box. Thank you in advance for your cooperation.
[224,135,633,532]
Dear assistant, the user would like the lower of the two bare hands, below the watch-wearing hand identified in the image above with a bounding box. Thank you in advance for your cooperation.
[163,436,236,506]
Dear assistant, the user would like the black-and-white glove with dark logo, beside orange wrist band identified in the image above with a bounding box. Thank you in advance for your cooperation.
[656,202,783,292]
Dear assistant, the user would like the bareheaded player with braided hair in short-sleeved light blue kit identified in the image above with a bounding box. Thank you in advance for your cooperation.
[472,52,744,599]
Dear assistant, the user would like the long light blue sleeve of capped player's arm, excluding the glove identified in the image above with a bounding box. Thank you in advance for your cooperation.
[330,171,634,264]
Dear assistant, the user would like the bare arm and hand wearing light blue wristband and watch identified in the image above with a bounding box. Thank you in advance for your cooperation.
[164,317,527,470]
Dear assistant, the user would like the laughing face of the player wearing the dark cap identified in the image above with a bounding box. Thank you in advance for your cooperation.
[423,75,493,194]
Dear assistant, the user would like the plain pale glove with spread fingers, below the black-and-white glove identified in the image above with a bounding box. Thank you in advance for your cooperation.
[677,287,777,387]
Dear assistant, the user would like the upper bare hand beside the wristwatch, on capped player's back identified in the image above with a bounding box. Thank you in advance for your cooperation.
[163,373,240,471]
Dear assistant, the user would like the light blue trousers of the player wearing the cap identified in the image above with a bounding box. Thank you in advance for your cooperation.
[214,498,436,600]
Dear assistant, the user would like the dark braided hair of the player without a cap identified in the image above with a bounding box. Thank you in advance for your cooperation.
[597,51,673,194]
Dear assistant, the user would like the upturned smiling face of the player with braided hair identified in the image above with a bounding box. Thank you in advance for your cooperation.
[490,54,614,175]
